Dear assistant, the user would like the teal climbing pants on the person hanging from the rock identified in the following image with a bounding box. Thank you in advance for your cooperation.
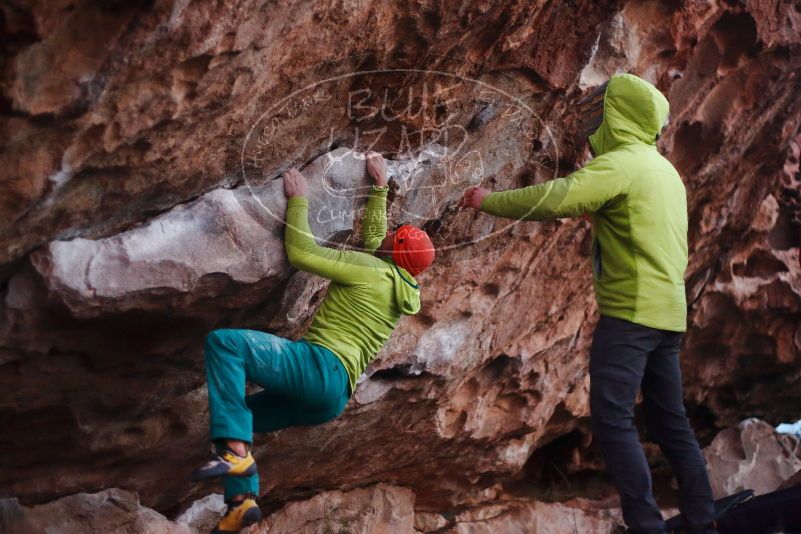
[205,330,350,499]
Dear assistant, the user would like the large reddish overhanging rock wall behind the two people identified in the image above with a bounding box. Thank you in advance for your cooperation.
[0,0,801,530]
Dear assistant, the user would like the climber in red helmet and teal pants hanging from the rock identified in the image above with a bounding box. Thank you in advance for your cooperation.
[191,152,434,533]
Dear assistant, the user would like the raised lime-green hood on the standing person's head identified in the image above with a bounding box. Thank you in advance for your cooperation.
[590,74,670,156]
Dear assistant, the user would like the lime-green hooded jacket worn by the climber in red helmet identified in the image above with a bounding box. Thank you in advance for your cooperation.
[284,187,420,391]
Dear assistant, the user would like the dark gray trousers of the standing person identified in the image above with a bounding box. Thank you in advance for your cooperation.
[590,317,715,534]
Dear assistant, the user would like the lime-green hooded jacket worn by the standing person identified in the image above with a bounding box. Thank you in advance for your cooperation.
[481,74,687,332]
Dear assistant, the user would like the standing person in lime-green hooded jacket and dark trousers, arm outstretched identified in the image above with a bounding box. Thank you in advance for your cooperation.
[460,74,715,533]
